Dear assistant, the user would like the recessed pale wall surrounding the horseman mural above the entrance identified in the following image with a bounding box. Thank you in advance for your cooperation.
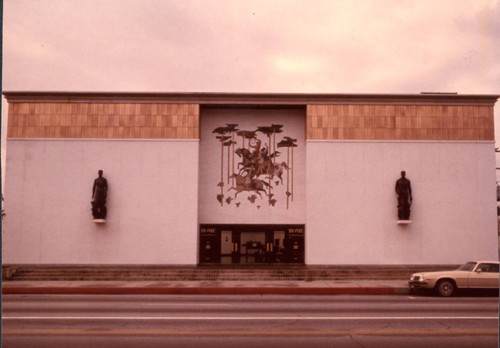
[199,108,306,224]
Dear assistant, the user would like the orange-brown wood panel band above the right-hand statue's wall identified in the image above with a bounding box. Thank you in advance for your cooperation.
[307,104,495,141]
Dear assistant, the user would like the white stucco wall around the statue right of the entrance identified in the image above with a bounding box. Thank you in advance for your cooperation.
[306,141,498,264]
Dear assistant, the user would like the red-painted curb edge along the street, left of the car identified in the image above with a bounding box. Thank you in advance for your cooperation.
[2,286,410,295]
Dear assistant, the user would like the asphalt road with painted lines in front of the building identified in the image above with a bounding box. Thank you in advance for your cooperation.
[2,295,499,348]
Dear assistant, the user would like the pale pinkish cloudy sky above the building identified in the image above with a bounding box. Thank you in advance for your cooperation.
[2,0,500,184]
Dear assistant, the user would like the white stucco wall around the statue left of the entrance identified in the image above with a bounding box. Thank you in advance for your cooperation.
[2,139,199,264]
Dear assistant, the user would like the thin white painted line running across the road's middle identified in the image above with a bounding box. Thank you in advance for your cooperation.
[2,316,499,321]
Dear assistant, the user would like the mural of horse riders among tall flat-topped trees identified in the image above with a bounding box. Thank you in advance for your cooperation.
[212,124,297,209]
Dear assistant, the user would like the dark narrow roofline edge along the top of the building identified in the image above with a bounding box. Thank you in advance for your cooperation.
[3,91,500,106]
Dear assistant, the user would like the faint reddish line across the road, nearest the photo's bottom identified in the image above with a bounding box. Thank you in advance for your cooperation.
[2,330,498,336]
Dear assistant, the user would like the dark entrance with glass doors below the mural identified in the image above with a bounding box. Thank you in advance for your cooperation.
[199,224,304,264]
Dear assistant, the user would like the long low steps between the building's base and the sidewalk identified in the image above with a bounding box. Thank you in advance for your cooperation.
[2,264,459,281]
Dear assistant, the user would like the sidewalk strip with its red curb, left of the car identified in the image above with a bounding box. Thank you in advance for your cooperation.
[2,280,410,295]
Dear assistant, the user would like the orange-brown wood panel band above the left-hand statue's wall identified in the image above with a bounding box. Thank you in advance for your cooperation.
[7,103,199,139]
